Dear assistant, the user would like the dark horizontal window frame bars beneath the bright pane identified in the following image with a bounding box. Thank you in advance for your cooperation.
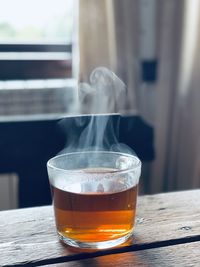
[0,43,72,80]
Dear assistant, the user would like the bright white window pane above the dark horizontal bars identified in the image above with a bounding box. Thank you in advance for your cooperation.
[0,0,74,43]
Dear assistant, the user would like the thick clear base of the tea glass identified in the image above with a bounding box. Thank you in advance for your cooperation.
[58,231,133,249]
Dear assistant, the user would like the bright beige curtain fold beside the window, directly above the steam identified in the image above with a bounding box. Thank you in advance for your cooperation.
[79,0,116,81]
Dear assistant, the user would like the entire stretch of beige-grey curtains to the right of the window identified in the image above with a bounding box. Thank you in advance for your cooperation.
[79,0,200,193]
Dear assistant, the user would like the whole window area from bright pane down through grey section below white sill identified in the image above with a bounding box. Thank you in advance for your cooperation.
[0,0,76,115]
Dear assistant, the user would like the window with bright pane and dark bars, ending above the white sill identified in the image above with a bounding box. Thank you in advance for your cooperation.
[0,0,74,80]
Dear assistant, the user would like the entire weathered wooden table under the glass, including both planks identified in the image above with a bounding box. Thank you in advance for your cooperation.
[0,190,200,267]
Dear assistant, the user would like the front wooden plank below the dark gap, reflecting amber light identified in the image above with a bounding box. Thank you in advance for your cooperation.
[45,242,200,267]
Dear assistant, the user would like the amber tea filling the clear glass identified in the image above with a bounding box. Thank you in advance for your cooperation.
[52,173,137,242]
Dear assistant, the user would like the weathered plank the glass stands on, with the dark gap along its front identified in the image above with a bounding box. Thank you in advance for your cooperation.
[0,190,200,266]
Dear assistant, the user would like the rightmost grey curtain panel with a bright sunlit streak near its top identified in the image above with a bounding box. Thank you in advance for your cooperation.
[150,0,200,192]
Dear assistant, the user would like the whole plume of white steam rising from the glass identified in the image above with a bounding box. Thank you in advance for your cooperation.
[61,67,134,153]
